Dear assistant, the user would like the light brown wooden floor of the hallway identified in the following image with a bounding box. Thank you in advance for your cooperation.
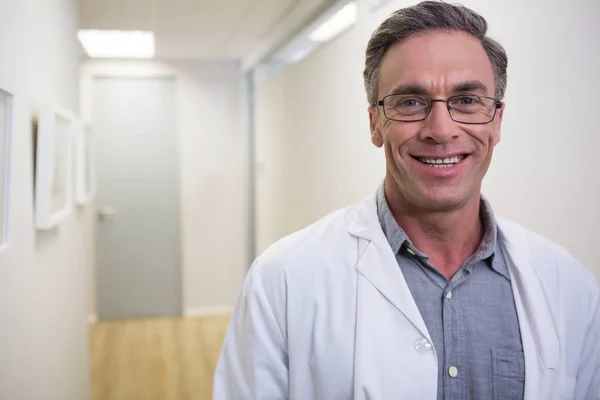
[91,315,229,400]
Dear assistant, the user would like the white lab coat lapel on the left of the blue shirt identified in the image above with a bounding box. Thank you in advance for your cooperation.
[349,196,431,342]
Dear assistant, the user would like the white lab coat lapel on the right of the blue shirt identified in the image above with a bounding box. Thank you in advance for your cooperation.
[498,219,560,400]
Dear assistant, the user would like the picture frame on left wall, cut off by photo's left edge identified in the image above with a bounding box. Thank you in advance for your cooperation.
[0,89,13,252]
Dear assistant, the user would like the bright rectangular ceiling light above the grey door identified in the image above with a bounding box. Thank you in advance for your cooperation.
[77,30,154,58]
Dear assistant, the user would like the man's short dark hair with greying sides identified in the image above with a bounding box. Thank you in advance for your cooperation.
[363,1,508,105]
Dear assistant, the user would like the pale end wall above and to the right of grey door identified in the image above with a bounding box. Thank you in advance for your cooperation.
[81,60,248,315]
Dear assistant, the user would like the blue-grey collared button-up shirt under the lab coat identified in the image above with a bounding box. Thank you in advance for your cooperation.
[377,184,525,400]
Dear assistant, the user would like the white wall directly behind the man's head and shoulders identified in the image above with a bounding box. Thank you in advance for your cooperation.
[257,0,600,277]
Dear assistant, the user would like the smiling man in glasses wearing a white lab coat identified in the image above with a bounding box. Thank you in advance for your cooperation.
[214,2,600,400]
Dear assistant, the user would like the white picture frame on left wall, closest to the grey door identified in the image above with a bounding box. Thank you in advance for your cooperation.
[74,121,96,205]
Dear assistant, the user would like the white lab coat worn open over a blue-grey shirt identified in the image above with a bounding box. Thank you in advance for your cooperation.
[213,196,600,400]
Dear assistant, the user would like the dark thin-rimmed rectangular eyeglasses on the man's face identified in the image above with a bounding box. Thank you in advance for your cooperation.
[373,94,504,124]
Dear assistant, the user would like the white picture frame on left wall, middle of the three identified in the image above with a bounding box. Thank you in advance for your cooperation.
[35,108,75,230]
